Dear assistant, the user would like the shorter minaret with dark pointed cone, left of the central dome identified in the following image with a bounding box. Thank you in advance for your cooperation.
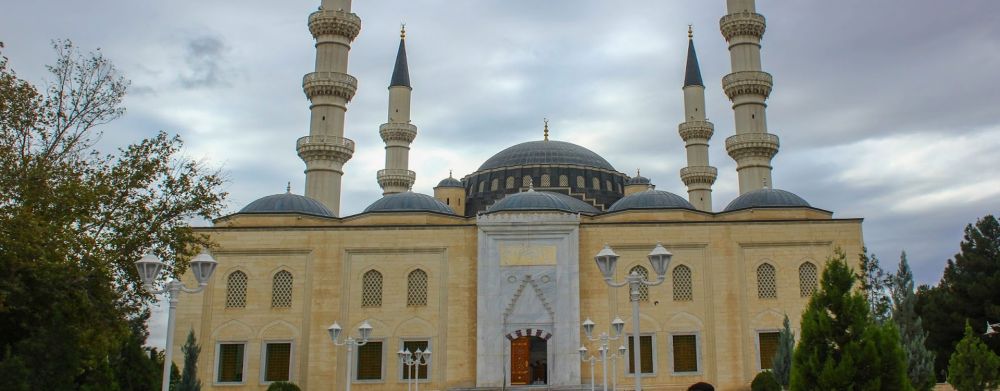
[377,25,417,195]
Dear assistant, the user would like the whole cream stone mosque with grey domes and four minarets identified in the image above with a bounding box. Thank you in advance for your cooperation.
[174,0,863,391]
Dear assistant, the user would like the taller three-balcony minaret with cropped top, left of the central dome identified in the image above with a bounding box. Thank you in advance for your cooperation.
[295,0,361,215]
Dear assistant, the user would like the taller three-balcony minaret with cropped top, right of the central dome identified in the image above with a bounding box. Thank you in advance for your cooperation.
[719,0,778,194]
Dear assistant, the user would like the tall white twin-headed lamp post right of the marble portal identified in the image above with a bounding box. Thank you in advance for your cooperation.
[594,243,673,391]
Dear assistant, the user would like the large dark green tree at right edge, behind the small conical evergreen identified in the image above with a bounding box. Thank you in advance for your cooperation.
[917,215,1000,380]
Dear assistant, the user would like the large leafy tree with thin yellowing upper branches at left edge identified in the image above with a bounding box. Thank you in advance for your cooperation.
[0,41,225,390]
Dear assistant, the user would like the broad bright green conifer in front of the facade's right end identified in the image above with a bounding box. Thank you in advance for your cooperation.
[790,249,912,391]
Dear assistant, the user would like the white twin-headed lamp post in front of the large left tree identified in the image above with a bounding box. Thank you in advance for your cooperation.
[135,251,218,391]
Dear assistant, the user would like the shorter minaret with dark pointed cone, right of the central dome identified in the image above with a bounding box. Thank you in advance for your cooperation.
[677,26,718,212]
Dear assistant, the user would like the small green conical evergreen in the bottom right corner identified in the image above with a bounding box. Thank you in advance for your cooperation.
[948,322,1000,391]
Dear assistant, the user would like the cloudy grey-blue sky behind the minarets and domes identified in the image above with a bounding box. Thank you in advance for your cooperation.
[0,0,1000,350]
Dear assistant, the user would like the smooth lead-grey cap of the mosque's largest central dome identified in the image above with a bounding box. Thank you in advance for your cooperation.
[477,140,615,171]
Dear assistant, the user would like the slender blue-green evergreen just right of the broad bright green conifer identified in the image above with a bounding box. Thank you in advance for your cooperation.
[891,252,935,391]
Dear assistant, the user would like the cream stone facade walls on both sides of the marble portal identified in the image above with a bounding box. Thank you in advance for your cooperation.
[175,209,862,390]
